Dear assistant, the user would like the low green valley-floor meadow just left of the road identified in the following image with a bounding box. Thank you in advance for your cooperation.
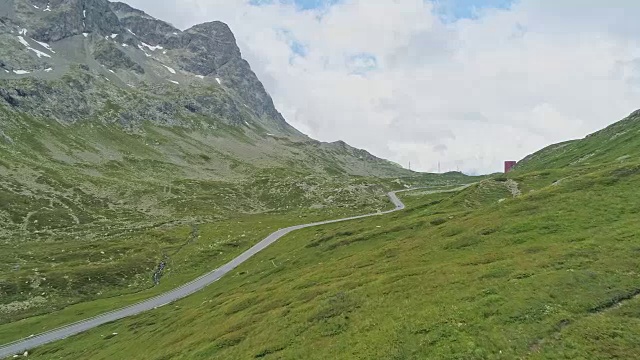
[0,208,400,343]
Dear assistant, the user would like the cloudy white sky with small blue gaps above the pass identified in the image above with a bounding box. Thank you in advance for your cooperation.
[126,0,640,173]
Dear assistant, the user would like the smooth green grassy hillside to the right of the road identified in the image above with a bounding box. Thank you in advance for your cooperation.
[5,111,640,359]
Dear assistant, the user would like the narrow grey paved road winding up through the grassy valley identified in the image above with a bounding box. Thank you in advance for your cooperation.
[0,189,416,359]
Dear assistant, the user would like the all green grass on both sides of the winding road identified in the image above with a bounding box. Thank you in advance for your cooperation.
[6,74,640,359]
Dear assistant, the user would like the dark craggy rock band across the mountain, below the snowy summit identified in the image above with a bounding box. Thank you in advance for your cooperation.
[0,63,252,128]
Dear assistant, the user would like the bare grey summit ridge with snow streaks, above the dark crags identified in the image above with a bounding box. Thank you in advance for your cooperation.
[1,0,301,136]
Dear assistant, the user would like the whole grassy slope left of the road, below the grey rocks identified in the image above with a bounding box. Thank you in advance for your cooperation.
[0,105,470,332]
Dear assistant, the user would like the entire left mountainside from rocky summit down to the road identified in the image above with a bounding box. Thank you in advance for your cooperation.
[0,0,480,334]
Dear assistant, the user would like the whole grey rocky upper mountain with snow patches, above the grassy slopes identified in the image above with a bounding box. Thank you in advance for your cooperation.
[0,0,301,136]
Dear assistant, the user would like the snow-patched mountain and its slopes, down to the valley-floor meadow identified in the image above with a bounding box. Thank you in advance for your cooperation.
[0,0,430,242]
